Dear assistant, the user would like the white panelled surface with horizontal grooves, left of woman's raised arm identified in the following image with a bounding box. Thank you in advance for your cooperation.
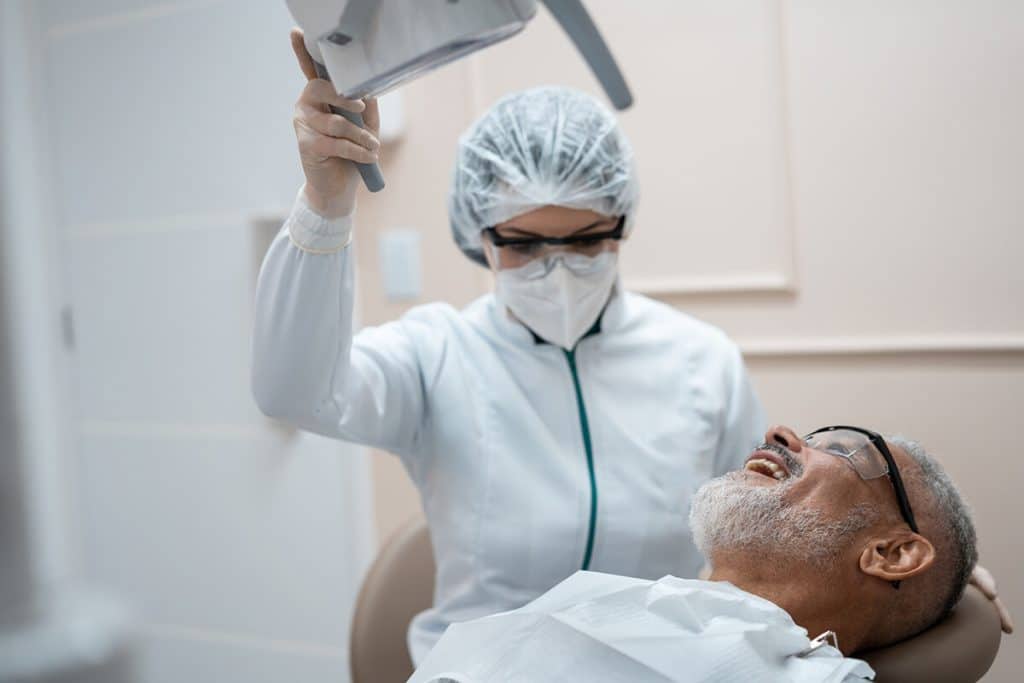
[30,0,374,683]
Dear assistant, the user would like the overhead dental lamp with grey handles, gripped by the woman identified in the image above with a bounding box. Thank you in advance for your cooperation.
[286,0,633,193]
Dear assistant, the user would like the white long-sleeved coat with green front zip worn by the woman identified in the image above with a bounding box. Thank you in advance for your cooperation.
[253,194,764,661]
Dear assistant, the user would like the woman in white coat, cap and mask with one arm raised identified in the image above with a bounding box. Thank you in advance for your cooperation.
[253,30,765,663]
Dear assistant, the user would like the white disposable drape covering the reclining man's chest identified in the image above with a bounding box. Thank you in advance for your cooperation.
[410,571,874,683]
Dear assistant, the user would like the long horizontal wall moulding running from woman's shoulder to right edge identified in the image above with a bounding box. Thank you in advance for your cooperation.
[737,334,1024,358]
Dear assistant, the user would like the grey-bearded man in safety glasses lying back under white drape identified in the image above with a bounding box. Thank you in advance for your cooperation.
[411,427,977,683]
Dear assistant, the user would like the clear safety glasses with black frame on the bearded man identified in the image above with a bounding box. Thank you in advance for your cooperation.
[804,425,920,589]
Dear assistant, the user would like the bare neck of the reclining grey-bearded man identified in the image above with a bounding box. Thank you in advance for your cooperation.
[710,556,869,655]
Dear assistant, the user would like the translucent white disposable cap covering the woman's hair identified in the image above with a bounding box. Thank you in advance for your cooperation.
[449,87,639,265]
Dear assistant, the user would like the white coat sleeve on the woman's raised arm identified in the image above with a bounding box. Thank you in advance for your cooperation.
[252,193,425,455]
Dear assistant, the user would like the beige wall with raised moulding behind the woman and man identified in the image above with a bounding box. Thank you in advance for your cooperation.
[358,0,1024,681]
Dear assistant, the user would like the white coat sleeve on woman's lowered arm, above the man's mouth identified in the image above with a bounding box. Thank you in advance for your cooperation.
[715,342,767,476]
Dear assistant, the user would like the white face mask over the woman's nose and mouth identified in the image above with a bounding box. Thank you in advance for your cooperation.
[495,252,618,350]
